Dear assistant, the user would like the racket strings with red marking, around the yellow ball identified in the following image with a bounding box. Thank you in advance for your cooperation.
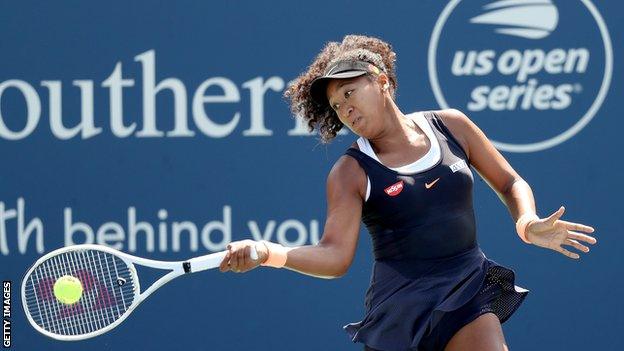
[25,250,136,335]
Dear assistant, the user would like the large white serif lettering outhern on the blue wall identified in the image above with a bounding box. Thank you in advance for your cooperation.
[0,50,316,140]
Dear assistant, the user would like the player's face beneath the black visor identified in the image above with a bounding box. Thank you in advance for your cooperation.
[327,75,384,139]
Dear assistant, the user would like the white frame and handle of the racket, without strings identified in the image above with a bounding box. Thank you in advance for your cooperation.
[21,244,258,341]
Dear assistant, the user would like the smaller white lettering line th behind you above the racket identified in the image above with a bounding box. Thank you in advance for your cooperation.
[0,197,320,256]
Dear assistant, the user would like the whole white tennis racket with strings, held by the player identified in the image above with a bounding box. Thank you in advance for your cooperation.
[22,245,258,341]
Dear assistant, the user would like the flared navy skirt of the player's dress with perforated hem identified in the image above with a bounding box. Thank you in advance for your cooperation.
[344,246,528,351]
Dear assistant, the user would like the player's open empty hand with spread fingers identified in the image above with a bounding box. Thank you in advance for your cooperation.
[526,206,596,259]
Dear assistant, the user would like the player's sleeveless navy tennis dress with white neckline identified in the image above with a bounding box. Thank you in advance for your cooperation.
[345,112,528,351]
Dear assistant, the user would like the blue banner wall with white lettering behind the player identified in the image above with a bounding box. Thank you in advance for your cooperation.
[0,0,624,351]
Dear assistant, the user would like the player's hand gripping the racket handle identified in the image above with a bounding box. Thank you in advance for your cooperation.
[219,240,269,273]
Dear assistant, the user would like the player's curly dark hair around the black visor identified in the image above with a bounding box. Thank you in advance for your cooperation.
[284,35,397,143]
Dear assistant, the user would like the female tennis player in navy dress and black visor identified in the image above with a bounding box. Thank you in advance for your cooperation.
[220,35,596,351]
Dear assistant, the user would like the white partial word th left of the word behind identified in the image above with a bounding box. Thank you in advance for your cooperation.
[0,197,44,255]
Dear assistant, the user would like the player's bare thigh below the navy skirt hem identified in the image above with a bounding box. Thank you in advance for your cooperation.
[444,313,508,351]
